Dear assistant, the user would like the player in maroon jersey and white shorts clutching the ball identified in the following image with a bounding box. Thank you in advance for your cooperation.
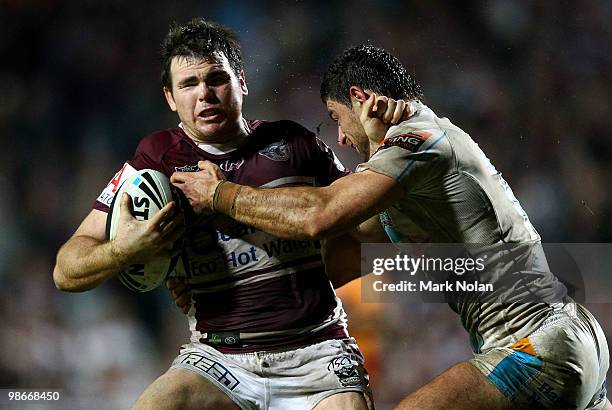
[53,19,371,409]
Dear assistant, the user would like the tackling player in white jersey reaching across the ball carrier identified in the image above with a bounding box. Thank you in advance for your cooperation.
[172,45,612,410]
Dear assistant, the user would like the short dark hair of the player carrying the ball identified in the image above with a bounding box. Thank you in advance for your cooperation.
[161,18,243,90]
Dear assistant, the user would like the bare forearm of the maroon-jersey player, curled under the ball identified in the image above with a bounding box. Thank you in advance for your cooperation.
[53,236,126,292]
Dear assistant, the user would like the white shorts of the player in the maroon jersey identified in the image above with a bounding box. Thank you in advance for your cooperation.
[170,338,371,410]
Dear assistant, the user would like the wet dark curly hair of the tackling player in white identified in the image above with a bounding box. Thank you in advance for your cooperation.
[321,44,423,107]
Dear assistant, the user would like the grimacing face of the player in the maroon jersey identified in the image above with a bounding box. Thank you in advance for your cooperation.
[164,54,248,142]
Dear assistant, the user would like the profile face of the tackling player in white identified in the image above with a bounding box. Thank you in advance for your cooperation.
[326,100,370,160]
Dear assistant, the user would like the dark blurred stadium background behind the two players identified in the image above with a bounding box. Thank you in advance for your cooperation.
[0,0,612,409]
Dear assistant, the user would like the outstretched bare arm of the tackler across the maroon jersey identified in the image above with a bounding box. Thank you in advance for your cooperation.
[171,162,402,239]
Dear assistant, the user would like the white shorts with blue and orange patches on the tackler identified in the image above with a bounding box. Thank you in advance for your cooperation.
[471,303,609,410]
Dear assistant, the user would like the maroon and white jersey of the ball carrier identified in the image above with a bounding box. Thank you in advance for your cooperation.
[94,121,348,352]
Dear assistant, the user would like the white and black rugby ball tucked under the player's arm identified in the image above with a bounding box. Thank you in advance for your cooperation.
[106,169,177,292]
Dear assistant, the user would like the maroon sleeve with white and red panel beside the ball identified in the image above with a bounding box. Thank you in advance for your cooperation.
[93,139,161,213]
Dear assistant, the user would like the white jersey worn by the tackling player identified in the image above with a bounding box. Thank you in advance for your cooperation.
[357,101,566,352]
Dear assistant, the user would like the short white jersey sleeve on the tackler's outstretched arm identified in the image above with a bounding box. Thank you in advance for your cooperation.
[357,126,452,193]
